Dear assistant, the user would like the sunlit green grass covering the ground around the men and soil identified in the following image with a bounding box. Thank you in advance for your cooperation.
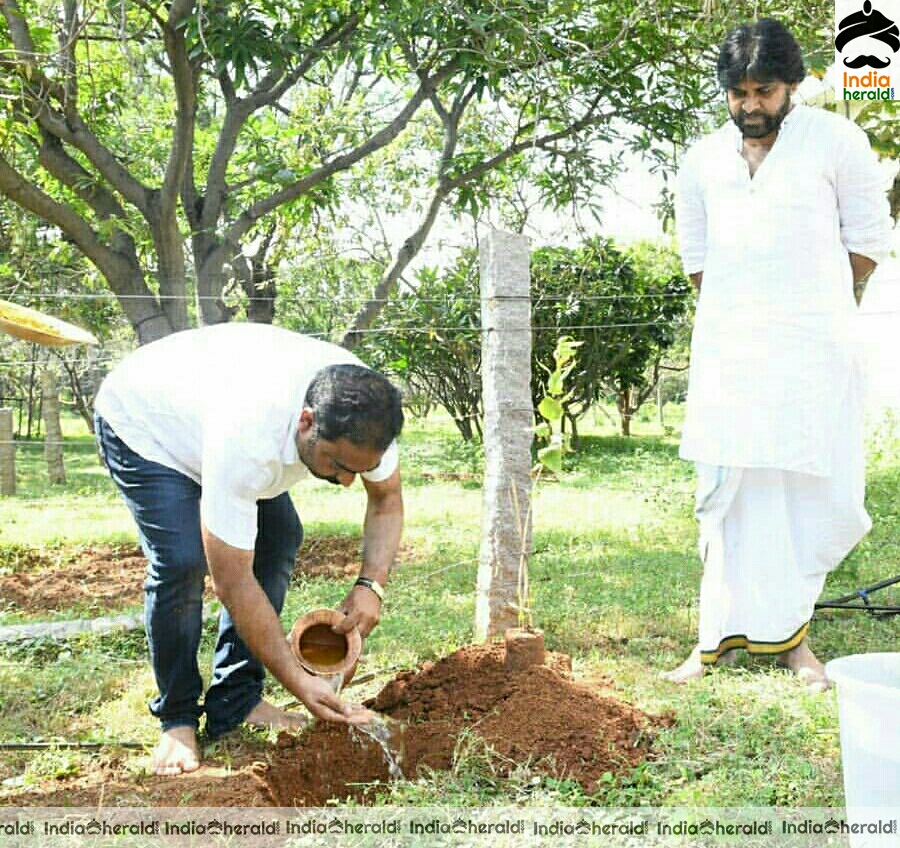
[0,408,900,806]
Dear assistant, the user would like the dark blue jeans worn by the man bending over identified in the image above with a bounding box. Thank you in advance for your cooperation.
[94,415,303,737]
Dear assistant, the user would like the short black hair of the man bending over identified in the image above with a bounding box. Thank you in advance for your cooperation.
[303,364,403,451]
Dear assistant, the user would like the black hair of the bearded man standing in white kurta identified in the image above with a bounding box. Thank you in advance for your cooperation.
[716,18,806,91]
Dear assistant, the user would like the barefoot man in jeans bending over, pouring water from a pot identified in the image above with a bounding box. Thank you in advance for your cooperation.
[95,324,403,774]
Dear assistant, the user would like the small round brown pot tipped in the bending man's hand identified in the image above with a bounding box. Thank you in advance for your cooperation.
[288,609,362,691]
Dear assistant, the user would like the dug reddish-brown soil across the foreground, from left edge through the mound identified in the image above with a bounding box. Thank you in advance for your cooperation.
[0,644,663,807]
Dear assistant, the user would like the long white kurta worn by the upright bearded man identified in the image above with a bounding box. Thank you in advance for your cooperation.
[676,106,891,476]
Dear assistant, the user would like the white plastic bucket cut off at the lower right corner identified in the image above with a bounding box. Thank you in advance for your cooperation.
[825,653,900,848]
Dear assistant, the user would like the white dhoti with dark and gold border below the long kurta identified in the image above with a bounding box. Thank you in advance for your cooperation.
[696,372,872,663]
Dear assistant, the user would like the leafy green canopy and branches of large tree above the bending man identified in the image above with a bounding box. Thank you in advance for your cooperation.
[0,0,829,346]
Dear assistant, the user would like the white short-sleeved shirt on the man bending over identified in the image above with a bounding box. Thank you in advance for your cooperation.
[94,323,399,550]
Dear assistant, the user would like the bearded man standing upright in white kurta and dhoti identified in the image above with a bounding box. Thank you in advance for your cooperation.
[664,19,890,688]
